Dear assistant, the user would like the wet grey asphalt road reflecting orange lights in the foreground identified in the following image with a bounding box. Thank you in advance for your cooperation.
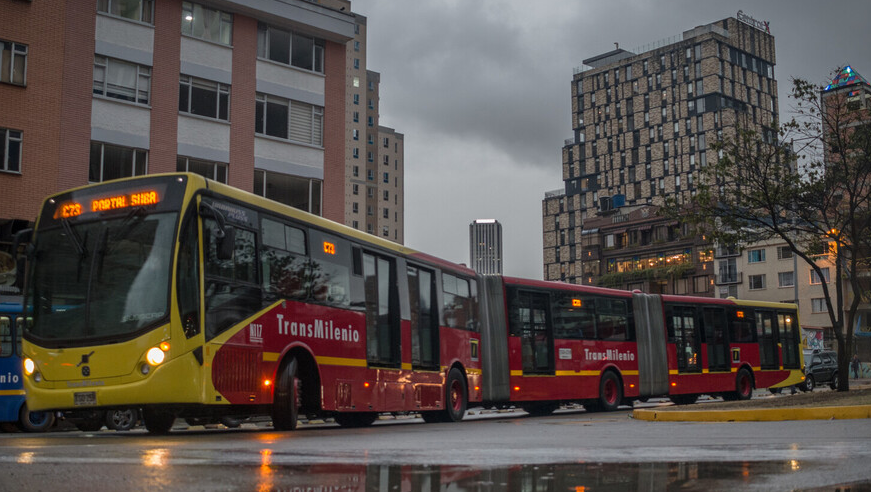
[0,410,871,492]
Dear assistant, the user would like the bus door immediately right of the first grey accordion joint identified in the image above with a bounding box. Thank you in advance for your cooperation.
[514,291,554,374]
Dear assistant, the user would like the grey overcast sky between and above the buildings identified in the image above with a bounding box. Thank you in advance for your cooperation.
[352,0,871,279]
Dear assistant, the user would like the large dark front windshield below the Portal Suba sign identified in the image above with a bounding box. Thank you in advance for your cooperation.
[28,208,178,344]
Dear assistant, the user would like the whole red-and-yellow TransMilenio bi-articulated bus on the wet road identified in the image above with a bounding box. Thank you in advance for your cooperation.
[23,174,802,433]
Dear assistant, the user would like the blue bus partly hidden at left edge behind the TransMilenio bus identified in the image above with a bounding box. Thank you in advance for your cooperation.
[0,296,55,432]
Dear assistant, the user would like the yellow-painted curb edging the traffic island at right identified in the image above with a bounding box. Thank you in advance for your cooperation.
[632,405,871,422]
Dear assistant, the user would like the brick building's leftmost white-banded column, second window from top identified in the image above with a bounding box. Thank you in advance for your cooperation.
[94,55,151,104]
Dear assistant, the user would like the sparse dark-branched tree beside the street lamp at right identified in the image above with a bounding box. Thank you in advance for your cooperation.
[665,70,871,391]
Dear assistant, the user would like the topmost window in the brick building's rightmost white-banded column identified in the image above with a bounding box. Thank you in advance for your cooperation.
[257,22,328,73]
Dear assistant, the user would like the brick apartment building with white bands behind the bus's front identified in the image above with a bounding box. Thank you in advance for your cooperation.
[0,0,403,293]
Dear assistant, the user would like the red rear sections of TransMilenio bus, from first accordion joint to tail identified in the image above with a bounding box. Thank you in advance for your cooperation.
[482,277,802,414]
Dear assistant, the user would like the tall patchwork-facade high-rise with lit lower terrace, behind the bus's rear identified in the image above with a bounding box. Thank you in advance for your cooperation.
[543,13,778,296]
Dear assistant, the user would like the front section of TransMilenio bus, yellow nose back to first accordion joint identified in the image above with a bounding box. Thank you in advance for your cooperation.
[24,174,481,432]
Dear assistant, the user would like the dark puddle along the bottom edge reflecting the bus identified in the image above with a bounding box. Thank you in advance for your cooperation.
[240,461,871,492]
